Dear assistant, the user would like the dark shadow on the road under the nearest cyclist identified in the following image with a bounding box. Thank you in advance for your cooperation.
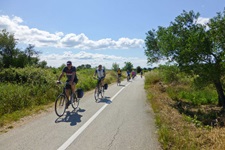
[55,108,85,126]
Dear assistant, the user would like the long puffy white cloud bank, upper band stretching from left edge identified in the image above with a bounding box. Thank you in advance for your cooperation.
[0,15,144,50]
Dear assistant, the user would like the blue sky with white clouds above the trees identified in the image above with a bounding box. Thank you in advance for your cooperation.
[0,0,225,69]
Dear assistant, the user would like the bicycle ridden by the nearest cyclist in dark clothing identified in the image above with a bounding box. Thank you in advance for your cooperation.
[55,82,80,117]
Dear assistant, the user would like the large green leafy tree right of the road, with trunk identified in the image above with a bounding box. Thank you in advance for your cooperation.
[145,11,225,108]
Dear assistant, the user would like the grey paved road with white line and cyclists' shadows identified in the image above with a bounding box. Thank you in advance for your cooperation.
[0,76,160,150]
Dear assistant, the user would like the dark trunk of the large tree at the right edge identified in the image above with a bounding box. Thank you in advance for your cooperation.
[214,80,225,108]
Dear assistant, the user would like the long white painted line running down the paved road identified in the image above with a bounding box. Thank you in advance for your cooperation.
[58,83,130,150]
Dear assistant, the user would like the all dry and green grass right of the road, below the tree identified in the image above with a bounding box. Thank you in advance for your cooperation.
[145,70,225,150]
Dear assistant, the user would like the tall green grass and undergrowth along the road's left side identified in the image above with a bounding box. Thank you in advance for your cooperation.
[0,68,116,129]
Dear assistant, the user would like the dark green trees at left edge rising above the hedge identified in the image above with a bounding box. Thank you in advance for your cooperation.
[0,30,47,68]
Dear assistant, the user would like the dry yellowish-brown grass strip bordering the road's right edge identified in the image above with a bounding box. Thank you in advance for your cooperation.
[145,72,225,150]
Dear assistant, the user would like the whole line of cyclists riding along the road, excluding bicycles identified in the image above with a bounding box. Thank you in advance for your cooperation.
[57,61,143,108]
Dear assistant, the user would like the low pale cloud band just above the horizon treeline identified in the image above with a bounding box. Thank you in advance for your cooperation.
[40,51,147,69]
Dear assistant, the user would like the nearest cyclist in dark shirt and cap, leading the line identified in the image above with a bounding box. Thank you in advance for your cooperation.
[58,61,78,109]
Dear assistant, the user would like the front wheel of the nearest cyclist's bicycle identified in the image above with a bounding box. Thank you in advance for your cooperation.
[55,94,67,117]
